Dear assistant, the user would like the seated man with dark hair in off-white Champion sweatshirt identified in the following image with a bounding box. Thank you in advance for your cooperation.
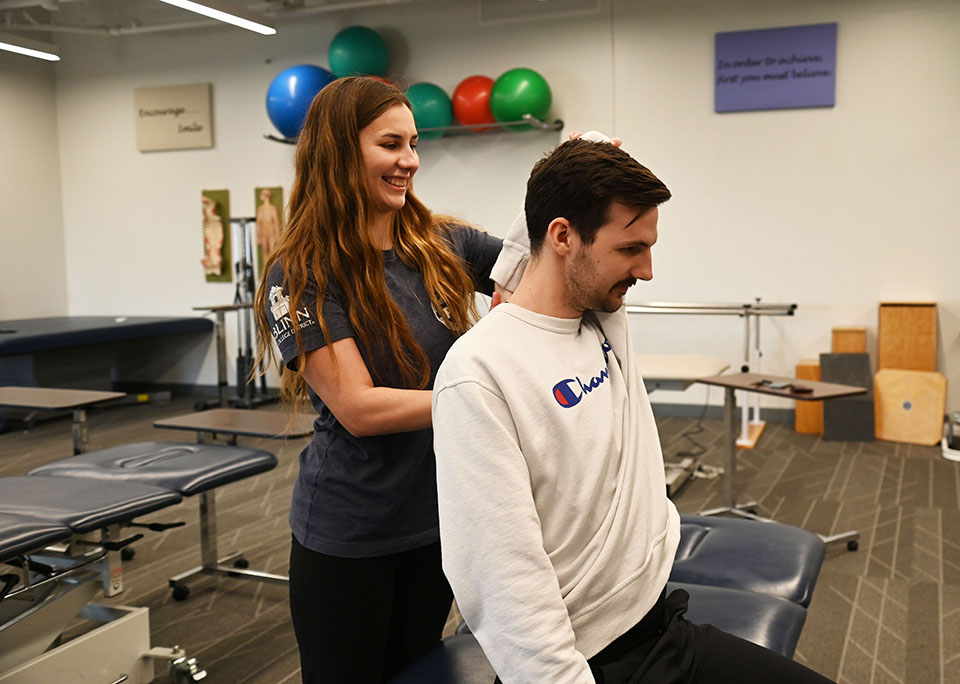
[433,140,827,684]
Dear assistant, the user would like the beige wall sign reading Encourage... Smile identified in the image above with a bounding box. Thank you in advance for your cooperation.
[133,83,213,152]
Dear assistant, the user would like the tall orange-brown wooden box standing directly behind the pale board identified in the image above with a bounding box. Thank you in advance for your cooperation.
[877,302,937,371]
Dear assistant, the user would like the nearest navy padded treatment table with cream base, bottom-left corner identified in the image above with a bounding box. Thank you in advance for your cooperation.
[0,486,206,684]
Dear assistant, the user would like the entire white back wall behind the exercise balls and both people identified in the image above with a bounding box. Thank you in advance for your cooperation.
[31,0,960,410]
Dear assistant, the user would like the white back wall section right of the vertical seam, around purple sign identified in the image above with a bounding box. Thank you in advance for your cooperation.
[614,0,960,410]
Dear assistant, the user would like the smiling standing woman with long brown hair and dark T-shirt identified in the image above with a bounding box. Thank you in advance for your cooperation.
[256,77,501,684]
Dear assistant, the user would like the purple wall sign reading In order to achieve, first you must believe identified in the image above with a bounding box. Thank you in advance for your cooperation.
[714,24,837,112]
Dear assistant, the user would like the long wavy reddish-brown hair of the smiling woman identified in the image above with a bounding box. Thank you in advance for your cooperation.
[254,77,478,407]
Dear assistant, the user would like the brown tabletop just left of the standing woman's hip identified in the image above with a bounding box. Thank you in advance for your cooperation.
[153,408,317,438]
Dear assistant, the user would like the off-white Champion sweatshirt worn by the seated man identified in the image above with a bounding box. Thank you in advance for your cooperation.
[433,194,680,684]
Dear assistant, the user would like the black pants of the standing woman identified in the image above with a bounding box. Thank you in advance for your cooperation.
[290,539,453,684]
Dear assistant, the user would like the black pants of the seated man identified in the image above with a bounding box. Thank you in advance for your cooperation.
[496,589,830,684]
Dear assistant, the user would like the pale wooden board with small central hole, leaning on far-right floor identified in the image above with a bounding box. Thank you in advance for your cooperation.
[873,368,947,446]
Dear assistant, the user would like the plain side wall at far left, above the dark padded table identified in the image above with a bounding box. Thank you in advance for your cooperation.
[0,52,67,320]
